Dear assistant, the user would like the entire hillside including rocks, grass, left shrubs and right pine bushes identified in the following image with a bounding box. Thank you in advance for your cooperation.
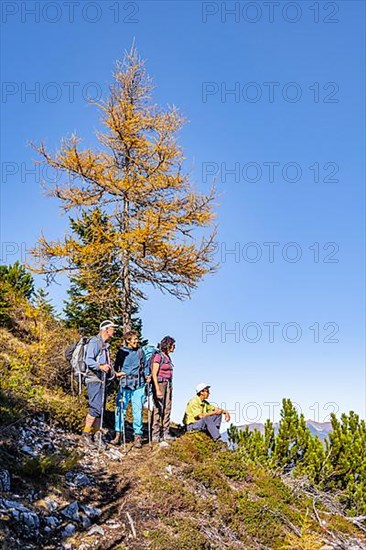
[0,274,366,550]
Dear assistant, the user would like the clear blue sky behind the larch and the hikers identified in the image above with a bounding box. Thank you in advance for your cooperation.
[1,0,365,430]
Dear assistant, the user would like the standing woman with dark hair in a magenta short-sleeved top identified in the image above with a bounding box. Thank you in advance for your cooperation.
[151,336,175,443]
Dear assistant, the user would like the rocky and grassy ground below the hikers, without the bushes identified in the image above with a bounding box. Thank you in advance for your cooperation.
[0,417,366,550]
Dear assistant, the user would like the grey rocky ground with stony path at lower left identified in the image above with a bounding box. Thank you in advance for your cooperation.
[0,418,167,550]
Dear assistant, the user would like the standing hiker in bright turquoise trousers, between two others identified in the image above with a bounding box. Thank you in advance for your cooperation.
[111,330,151,449]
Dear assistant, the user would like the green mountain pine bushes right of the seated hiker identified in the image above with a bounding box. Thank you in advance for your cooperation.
[229,399,366,516]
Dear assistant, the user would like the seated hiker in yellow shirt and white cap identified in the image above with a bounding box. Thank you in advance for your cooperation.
[183,383,230,441]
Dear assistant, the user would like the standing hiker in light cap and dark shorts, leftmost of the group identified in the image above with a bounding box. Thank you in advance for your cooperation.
[83,319,118,447]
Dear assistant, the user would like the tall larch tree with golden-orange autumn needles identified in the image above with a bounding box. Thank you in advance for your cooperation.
[33,46,216,330]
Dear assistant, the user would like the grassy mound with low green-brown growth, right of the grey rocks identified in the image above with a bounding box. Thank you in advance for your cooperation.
[64,434,366,550]
